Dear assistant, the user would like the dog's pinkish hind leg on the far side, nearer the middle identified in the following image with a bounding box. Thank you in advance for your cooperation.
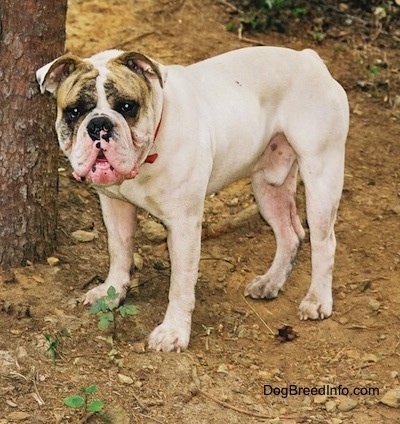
[245,134,305,299]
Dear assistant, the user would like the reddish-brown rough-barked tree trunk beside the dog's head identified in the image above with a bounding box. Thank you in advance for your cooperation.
[0,0,67,268]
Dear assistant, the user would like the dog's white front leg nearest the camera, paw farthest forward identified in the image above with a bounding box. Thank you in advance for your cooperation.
[149,216,201,352]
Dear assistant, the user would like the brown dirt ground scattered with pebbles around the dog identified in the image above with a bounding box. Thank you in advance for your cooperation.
[0,0,400,424]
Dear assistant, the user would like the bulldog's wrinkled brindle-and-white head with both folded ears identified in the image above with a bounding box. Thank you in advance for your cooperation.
[36,50,166,185]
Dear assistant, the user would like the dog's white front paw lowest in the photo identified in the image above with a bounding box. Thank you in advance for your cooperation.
[149,323,190,353]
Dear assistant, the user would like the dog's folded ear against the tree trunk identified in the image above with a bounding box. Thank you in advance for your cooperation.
[36,53,83,95]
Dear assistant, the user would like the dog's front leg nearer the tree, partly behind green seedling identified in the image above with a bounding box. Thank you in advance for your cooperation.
[85,193,136,303]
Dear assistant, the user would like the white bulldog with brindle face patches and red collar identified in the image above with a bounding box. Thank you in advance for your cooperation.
[37,47,349,352]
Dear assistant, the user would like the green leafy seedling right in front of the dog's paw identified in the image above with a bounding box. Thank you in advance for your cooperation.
[89,286,137,340]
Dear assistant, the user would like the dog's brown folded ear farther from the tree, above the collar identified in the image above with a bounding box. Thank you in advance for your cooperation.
[116,51,167,87]
